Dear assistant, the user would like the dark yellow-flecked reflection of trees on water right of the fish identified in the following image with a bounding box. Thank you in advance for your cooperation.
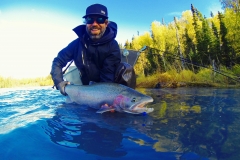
[145,88,240,159]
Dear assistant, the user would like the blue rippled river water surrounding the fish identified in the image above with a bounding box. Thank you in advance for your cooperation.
[0,87,240,160]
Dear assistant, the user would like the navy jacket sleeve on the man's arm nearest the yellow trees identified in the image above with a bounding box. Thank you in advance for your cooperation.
[100,40,121,82]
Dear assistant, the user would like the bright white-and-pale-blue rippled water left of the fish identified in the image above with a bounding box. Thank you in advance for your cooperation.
[0,87,63,134]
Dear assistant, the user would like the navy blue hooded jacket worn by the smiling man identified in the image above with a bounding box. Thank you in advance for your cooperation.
[50,22,121,86]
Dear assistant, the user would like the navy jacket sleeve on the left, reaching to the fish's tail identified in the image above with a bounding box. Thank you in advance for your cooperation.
[50,39,79,86]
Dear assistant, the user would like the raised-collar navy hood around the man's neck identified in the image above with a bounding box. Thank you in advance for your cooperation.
[73,21,117,45]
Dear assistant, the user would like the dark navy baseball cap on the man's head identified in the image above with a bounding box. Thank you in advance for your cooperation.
[83,4,108,18]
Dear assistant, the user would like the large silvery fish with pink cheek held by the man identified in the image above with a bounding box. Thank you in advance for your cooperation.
[65,82,154,114]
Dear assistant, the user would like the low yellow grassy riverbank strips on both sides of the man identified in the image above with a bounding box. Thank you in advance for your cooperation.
[0,69,240,88]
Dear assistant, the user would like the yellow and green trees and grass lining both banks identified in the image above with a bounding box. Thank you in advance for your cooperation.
[0,0,240,88]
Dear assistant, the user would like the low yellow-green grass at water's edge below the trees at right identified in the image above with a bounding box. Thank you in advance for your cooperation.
[137,68,240,88]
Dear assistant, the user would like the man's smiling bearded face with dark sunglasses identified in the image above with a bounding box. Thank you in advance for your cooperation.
[85,15,108,40]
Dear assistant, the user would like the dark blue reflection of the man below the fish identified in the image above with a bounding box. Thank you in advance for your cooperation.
[46,104,154,157]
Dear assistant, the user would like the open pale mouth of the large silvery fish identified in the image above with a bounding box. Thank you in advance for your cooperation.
[125,98,154,114]
